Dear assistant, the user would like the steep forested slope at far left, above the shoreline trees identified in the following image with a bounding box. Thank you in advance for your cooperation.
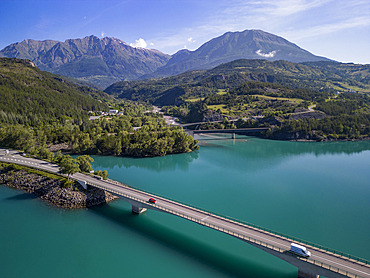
[0,58,109,126]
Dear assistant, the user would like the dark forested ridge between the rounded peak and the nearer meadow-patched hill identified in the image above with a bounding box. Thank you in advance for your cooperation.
[105,59,370,106]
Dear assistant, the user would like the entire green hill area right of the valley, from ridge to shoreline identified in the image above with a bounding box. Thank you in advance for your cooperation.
[106,60,370,140]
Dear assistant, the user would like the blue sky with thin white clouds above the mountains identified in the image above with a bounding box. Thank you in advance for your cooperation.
[0,0,370,64]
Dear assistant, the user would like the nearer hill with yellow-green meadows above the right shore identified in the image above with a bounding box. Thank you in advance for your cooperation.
[162,81,370,141]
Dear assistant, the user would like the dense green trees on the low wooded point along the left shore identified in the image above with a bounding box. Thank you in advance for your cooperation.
[0,104,198,159]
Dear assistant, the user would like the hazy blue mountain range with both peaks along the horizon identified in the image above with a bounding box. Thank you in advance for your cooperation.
[0,30,330,88]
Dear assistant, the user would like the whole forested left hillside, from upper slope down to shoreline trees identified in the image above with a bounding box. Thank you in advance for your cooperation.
[0,58,198,157]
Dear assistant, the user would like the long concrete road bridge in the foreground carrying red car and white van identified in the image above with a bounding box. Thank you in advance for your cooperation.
[0,149,370,278]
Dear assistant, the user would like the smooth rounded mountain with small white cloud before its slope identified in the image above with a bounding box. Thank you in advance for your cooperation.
[143,30,330,78]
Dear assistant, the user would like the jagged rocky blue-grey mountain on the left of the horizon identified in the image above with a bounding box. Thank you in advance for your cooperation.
[0,36,170,88]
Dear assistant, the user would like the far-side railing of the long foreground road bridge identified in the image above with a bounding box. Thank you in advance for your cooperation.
[94,177,370,265]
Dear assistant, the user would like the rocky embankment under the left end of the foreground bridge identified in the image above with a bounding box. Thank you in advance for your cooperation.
[0,165,117,209]
